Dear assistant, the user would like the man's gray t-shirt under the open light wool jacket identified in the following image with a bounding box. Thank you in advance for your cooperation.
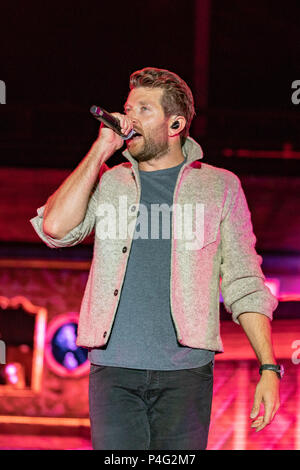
[89,159,214,370]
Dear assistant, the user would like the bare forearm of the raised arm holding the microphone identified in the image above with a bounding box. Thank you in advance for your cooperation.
[43,141,107,239]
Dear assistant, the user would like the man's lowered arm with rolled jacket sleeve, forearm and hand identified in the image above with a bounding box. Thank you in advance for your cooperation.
[220,174,280,431]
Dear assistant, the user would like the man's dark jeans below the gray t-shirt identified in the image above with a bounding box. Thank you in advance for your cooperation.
[89,362,213,450]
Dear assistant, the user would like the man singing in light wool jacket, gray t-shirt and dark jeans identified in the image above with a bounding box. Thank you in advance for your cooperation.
[31,67,280,450]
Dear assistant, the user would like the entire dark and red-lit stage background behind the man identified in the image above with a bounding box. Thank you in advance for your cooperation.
[0,0,300,449]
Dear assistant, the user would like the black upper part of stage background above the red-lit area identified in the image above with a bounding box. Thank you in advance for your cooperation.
[0,0,300,172]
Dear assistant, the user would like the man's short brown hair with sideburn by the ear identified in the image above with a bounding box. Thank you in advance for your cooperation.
[129,67,195,144]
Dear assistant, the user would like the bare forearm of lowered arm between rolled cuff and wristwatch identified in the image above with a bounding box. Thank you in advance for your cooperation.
[238,312,276,364]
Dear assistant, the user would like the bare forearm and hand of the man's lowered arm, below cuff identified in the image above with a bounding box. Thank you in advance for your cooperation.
[238,312,280,432]
